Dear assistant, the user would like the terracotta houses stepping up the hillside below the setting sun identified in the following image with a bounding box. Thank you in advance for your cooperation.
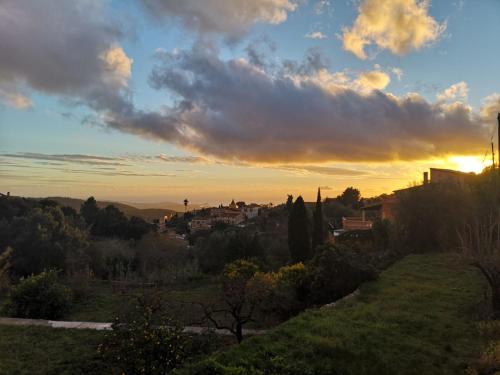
[333,168,475,237]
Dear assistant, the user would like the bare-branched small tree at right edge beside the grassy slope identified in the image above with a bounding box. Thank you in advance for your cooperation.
[459,209,500,319]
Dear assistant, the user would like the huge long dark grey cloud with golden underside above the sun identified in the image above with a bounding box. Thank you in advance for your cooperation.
[104,44,488,163]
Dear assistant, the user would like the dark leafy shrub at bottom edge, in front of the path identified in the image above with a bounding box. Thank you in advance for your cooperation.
[98,306,187,374]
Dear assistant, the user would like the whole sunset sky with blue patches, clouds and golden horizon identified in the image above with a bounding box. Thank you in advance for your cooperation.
[0,0,500,204]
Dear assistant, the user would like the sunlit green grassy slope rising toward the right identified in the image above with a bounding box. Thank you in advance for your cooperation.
[178,255,483,375]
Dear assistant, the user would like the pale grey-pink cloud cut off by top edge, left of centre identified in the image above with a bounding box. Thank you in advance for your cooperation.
[142,0,297,39]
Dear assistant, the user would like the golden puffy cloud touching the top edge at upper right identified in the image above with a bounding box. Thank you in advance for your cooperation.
[342,0,446,59]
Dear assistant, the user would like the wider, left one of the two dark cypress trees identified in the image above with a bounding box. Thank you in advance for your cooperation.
[288,196,312,263]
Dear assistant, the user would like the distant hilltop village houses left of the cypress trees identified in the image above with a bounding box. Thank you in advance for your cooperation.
[190,199,264,232]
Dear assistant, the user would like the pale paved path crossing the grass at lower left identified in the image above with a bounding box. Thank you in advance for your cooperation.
[0,317,267,336]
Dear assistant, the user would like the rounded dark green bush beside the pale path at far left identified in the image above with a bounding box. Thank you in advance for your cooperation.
[6,270,72,319]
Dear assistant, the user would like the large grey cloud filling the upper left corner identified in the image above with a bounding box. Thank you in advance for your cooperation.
[0,0,132,109]
